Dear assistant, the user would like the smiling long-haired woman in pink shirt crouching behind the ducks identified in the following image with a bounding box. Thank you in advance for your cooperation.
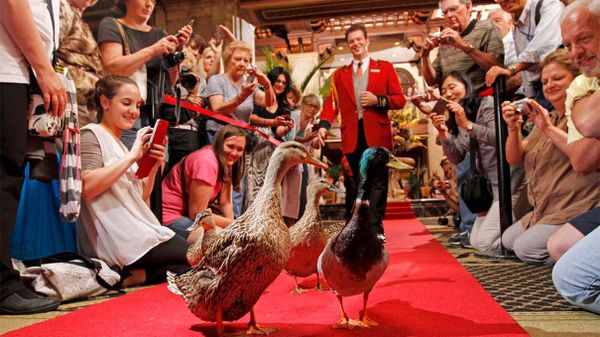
[162,125,247,243]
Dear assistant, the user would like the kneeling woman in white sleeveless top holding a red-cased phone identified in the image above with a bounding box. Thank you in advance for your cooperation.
[77,76,189,286]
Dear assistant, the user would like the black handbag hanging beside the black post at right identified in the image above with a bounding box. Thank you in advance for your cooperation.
[460,137,494,214]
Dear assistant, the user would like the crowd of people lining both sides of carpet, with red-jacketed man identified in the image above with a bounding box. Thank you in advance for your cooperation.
[0,0,600,314]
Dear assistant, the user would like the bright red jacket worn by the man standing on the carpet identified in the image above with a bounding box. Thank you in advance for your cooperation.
[321,59,405,154]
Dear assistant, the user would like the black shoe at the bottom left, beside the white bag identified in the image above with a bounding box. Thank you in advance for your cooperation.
[0,288,60,315]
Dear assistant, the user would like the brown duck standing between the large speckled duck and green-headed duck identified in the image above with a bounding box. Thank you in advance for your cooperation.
[285,177,337,294]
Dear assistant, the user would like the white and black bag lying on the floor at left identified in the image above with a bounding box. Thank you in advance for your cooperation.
[21,253,121,302]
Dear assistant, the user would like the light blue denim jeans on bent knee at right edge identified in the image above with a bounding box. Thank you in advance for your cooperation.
[552,227,600,314]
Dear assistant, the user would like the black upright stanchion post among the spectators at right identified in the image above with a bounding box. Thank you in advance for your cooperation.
[475,76,516,259]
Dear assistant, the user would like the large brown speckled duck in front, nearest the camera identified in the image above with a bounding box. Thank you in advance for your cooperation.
[168,142,327,336]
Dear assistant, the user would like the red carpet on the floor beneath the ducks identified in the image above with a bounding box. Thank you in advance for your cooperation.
[5,220,527,337]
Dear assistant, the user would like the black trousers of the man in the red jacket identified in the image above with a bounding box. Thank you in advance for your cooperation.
[344,119,389,234]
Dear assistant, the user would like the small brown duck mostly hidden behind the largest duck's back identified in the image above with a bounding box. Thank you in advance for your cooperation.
[187,208,223,267]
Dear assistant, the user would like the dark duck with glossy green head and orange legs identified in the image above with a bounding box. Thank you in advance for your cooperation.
[317,147,395,329]
